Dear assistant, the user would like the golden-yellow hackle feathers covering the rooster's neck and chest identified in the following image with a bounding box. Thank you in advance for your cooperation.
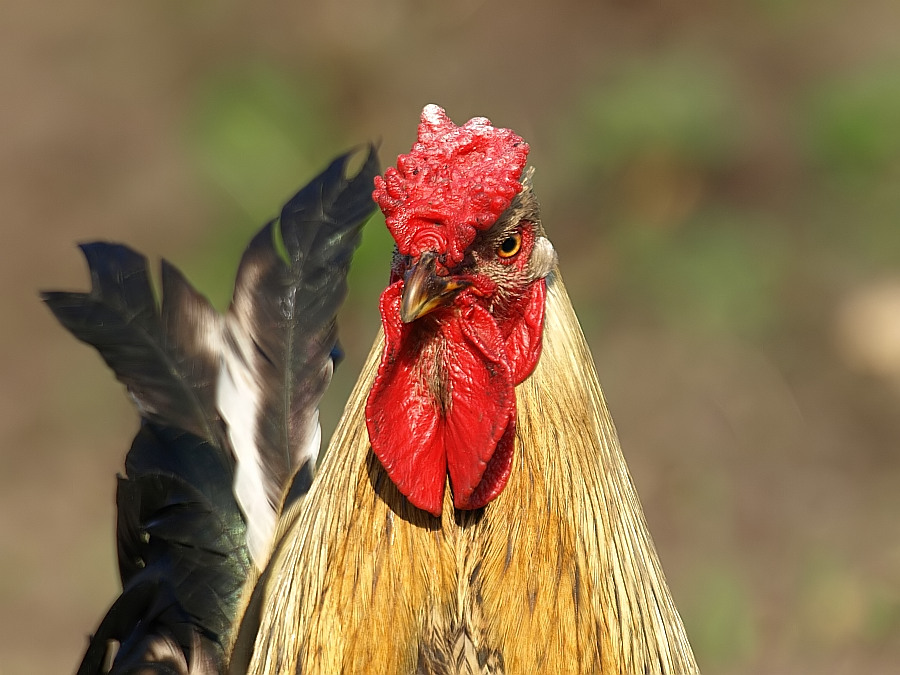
[232,271,697,675]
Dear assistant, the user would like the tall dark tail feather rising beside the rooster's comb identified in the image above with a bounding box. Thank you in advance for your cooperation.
[219,147,380,559]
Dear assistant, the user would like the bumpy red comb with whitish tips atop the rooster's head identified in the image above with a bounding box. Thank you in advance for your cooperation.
[372,105,528,265]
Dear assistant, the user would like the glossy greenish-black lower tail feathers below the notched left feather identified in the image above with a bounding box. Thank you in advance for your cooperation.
[78,422,251,675]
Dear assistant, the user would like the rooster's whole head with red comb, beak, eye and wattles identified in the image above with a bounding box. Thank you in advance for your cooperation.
[366,105,556,515]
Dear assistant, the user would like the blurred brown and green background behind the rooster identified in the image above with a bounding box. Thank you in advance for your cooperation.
[0,0,900,675]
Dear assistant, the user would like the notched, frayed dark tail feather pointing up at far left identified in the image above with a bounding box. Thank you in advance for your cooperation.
[42,248,223,445]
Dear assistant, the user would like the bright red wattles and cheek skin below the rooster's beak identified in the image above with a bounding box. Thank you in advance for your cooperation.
[366,226,546,515]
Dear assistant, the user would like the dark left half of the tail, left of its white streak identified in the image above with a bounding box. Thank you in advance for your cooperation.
[44,243,251,675]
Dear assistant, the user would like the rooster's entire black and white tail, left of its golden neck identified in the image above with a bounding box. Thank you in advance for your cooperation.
[43,147,378,675]
